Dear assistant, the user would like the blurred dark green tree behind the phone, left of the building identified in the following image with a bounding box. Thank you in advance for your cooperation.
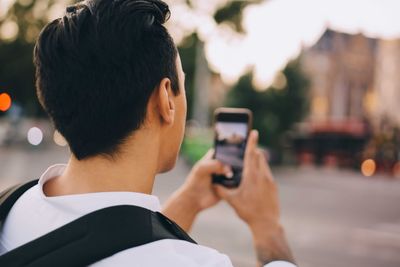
[226,60,309,162]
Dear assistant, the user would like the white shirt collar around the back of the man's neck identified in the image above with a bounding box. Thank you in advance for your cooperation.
[39,164,161,212]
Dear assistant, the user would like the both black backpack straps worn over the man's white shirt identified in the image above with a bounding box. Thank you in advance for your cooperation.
[0,180,197,267]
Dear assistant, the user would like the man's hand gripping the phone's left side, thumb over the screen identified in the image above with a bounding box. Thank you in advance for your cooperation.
[163,150,232,231]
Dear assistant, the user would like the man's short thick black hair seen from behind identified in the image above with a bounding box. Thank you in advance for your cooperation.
[34,0,179,160]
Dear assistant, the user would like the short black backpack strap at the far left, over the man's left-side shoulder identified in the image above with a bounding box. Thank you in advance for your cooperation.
[0,180,38,225]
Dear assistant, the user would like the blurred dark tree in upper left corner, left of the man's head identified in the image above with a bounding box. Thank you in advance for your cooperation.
[0,0,70,116]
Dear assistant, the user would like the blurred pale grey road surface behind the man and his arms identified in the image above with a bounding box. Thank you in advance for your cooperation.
[0,145,400,267]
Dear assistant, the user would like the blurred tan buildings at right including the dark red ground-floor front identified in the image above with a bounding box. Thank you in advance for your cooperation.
[294,29,400,166]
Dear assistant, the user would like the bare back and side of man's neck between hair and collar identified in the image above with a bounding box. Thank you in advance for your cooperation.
[44,131,159,196]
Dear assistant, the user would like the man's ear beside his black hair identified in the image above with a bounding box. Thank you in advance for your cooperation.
[157,78,175,124]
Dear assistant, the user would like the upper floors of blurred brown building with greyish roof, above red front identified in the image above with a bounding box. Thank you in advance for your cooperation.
[302,30,378,122]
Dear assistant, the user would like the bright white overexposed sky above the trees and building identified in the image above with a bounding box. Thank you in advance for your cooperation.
[0,0,400,90]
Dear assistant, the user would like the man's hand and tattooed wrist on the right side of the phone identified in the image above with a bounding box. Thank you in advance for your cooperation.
[215,130,293,266]
